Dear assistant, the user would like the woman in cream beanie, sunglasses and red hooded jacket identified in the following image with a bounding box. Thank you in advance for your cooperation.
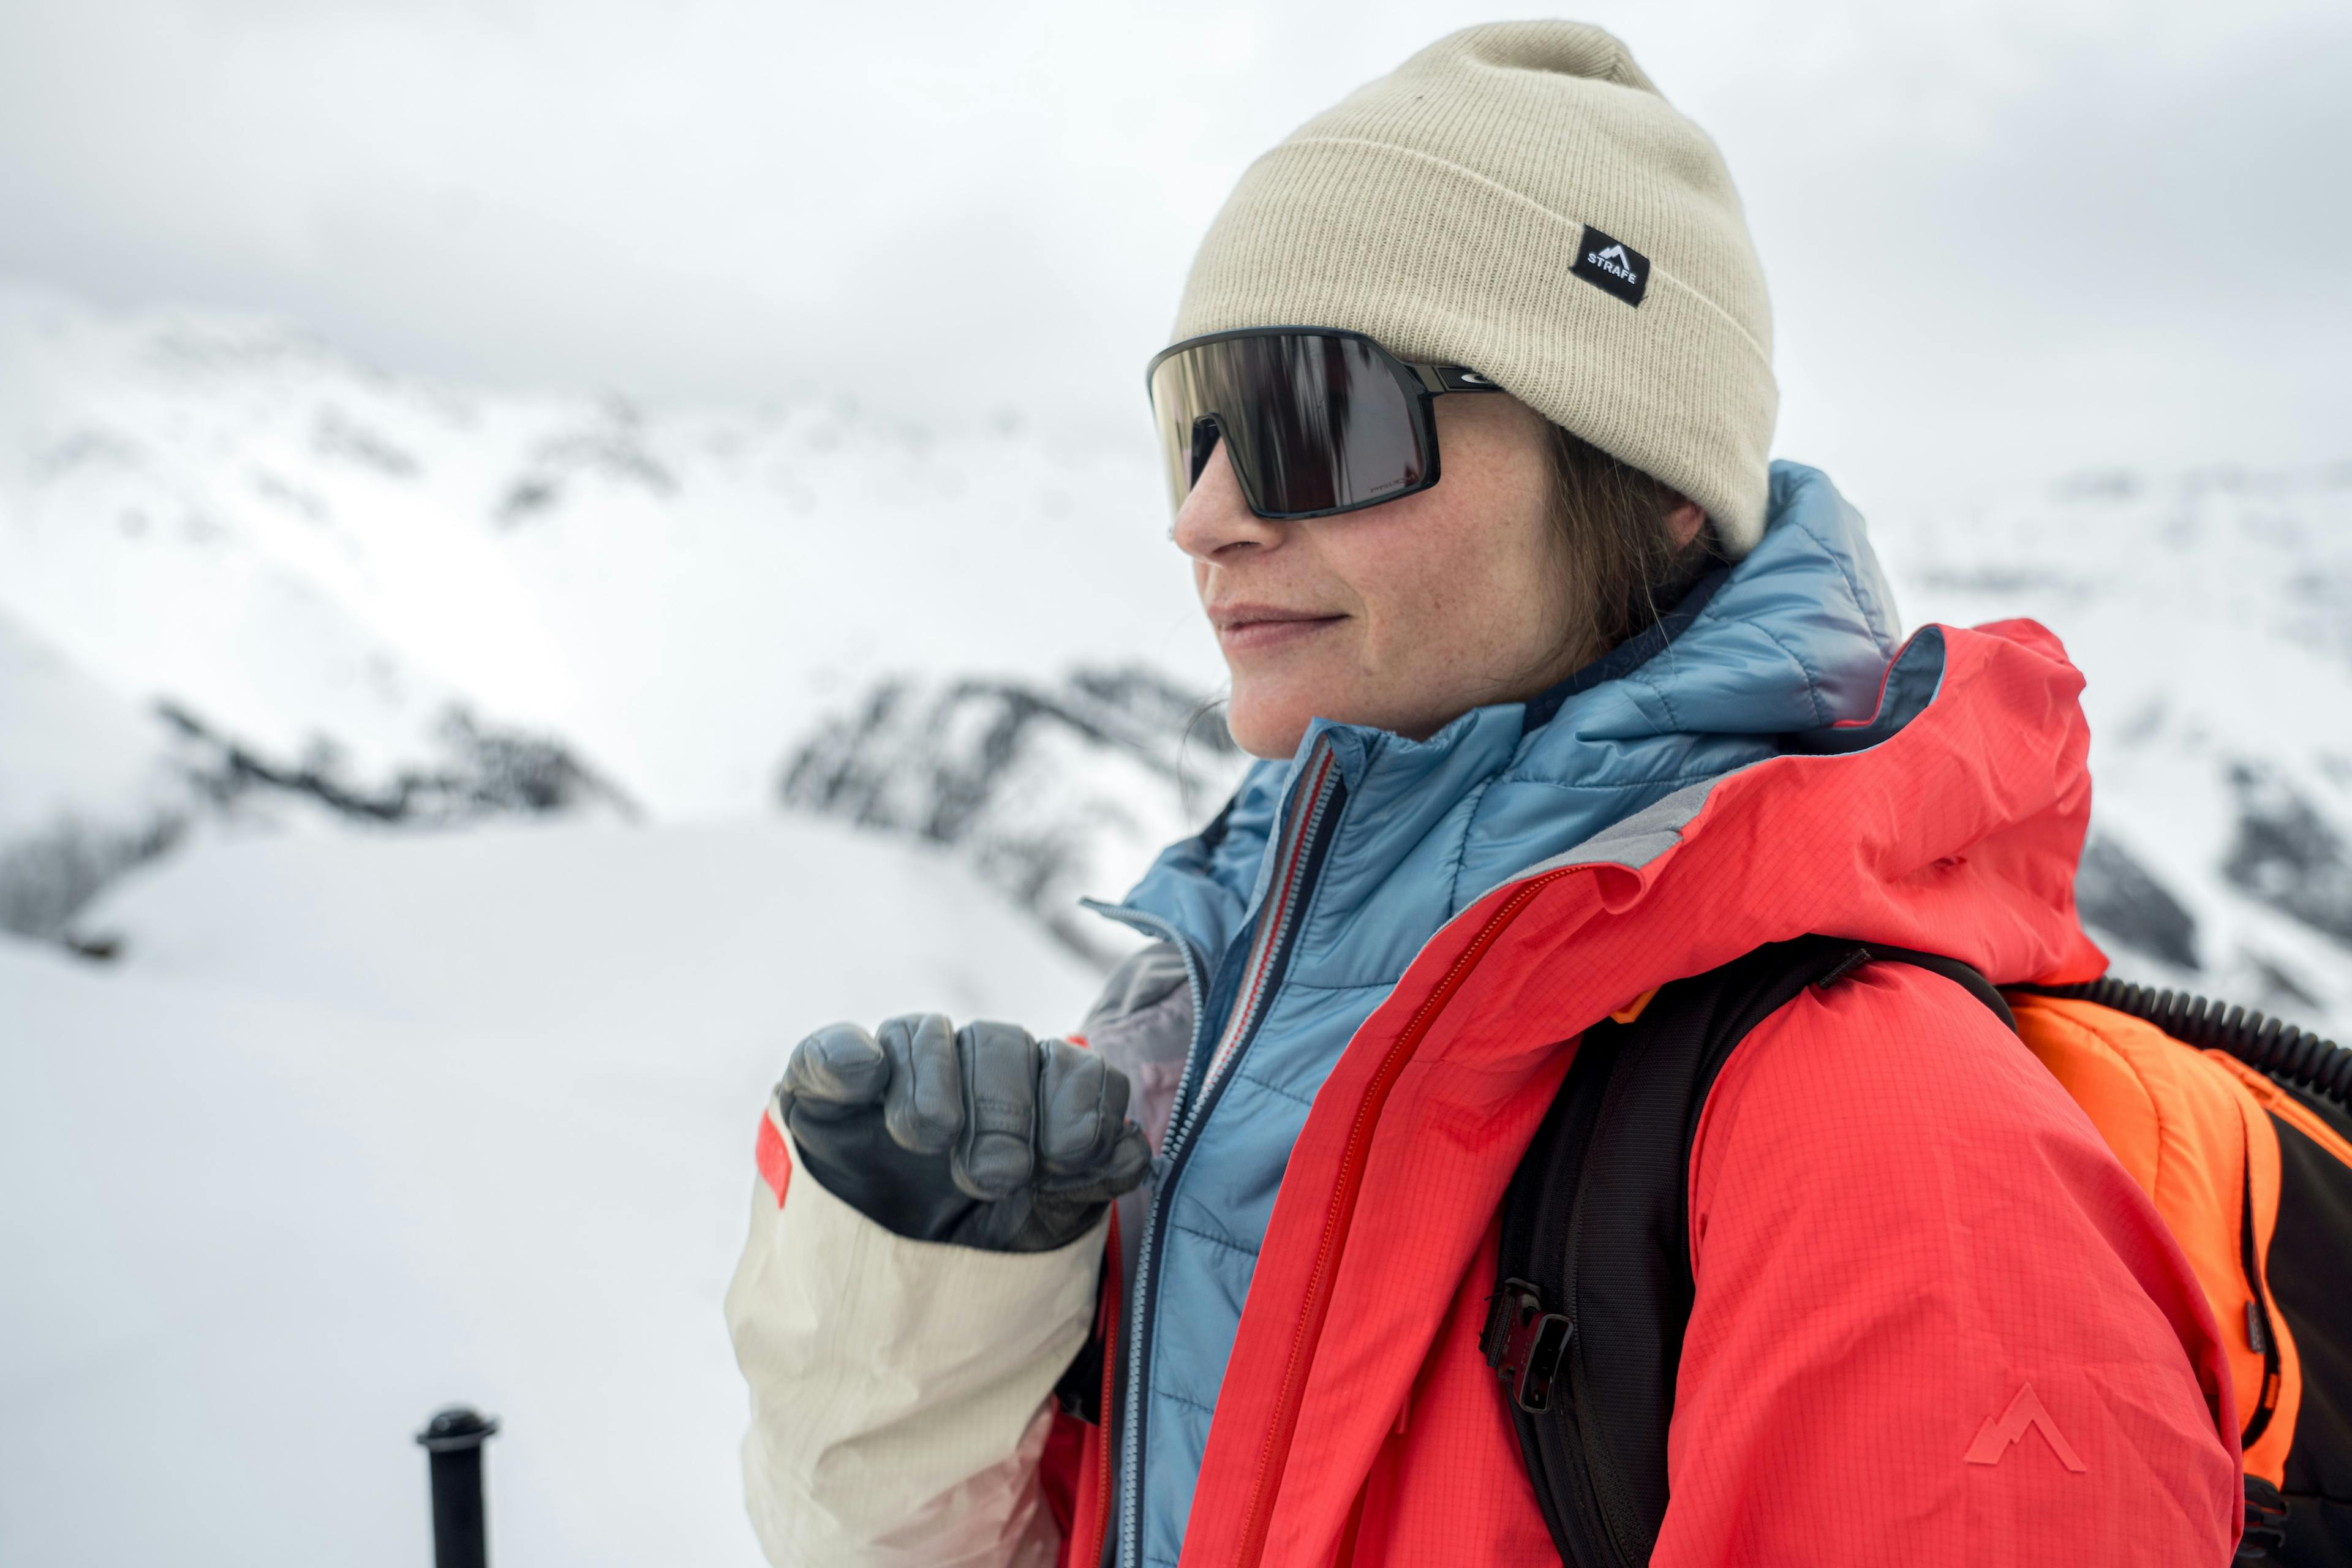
[727,23,2239,1568]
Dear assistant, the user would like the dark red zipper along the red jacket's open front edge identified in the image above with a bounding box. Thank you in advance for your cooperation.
[1232,865,1580,1568]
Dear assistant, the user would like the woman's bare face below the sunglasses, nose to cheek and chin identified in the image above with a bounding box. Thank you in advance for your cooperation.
[1174,393,1576,757]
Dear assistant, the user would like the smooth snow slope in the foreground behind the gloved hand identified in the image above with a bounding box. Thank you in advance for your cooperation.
[0,818,1094,1568]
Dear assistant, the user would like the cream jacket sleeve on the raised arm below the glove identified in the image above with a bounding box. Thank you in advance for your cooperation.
[727,1105,1103,1568]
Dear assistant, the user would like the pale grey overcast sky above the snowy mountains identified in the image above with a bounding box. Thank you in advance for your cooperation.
[0,0,2352,517]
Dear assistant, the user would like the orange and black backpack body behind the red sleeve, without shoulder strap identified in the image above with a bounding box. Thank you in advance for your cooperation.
[2008,980,2352,1563]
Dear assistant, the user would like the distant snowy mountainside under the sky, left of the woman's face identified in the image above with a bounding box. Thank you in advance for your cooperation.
[0,287,1216,816]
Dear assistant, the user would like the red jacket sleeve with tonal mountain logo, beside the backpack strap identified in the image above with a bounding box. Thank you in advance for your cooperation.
[1654,964,2244,1568]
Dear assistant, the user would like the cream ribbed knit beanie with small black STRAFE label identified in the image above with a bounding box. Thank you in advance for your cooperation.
[1176,21,1781,555]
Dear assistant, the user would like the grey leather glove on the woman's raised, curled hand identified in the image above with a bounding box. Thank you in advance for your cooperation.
[776,1013,1150,1253]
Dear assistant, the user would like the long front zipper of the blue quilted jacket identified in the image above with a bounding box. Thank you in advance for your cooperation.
[1117,741,1343,1568]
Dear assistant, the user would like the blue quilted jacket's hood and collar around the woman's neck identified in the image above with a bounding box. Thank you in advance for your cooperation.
[1101,463,1898,985]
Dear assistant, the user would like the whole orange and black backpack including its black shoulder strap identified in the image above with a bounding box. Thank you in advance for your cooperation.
[1482,936,2352,1568]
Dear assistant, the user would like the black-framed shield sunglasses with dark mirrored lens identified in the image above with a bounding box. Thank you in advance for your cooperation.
[1143,326,1503,522]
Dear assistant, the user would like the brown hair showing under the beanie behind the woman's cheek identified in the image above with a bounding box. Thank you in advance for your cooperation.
[1550,426,1724,670]
